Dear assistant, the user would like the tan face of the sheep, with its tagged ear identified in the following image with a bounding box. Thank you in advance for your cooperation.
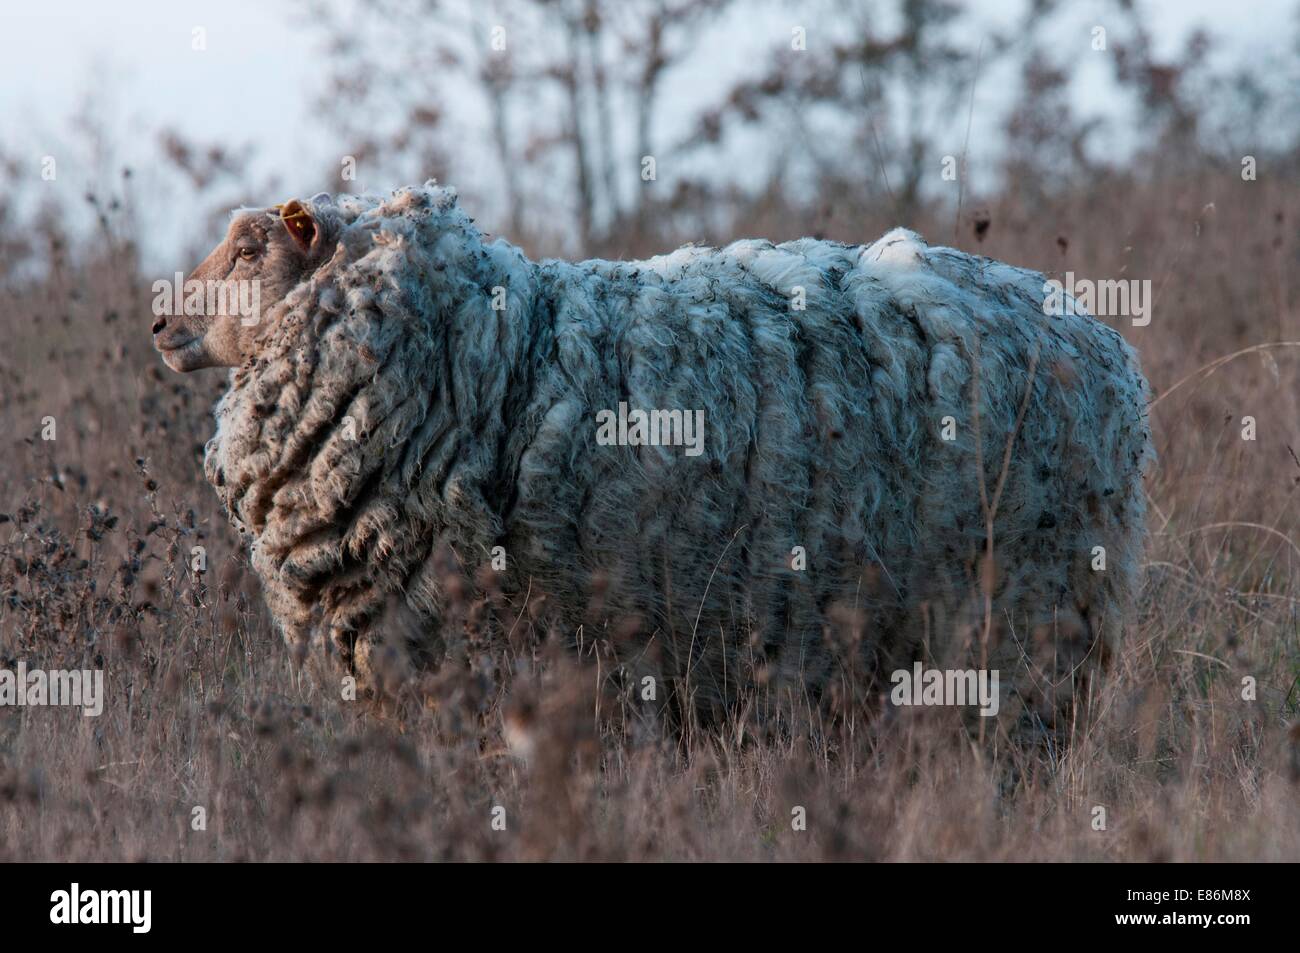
[153,200,326,373]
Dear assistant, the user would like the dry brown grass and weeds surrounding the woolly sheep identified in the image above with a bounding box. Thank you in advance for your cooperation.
[0,170,1300,861]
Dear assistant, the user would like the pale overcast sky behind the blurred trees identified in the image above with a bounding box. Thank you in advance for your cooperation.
[0,0,1296,263]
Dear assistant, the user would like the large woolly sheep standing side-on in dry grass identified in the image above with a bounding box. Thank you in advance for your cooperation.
[153,182,1153,718]
